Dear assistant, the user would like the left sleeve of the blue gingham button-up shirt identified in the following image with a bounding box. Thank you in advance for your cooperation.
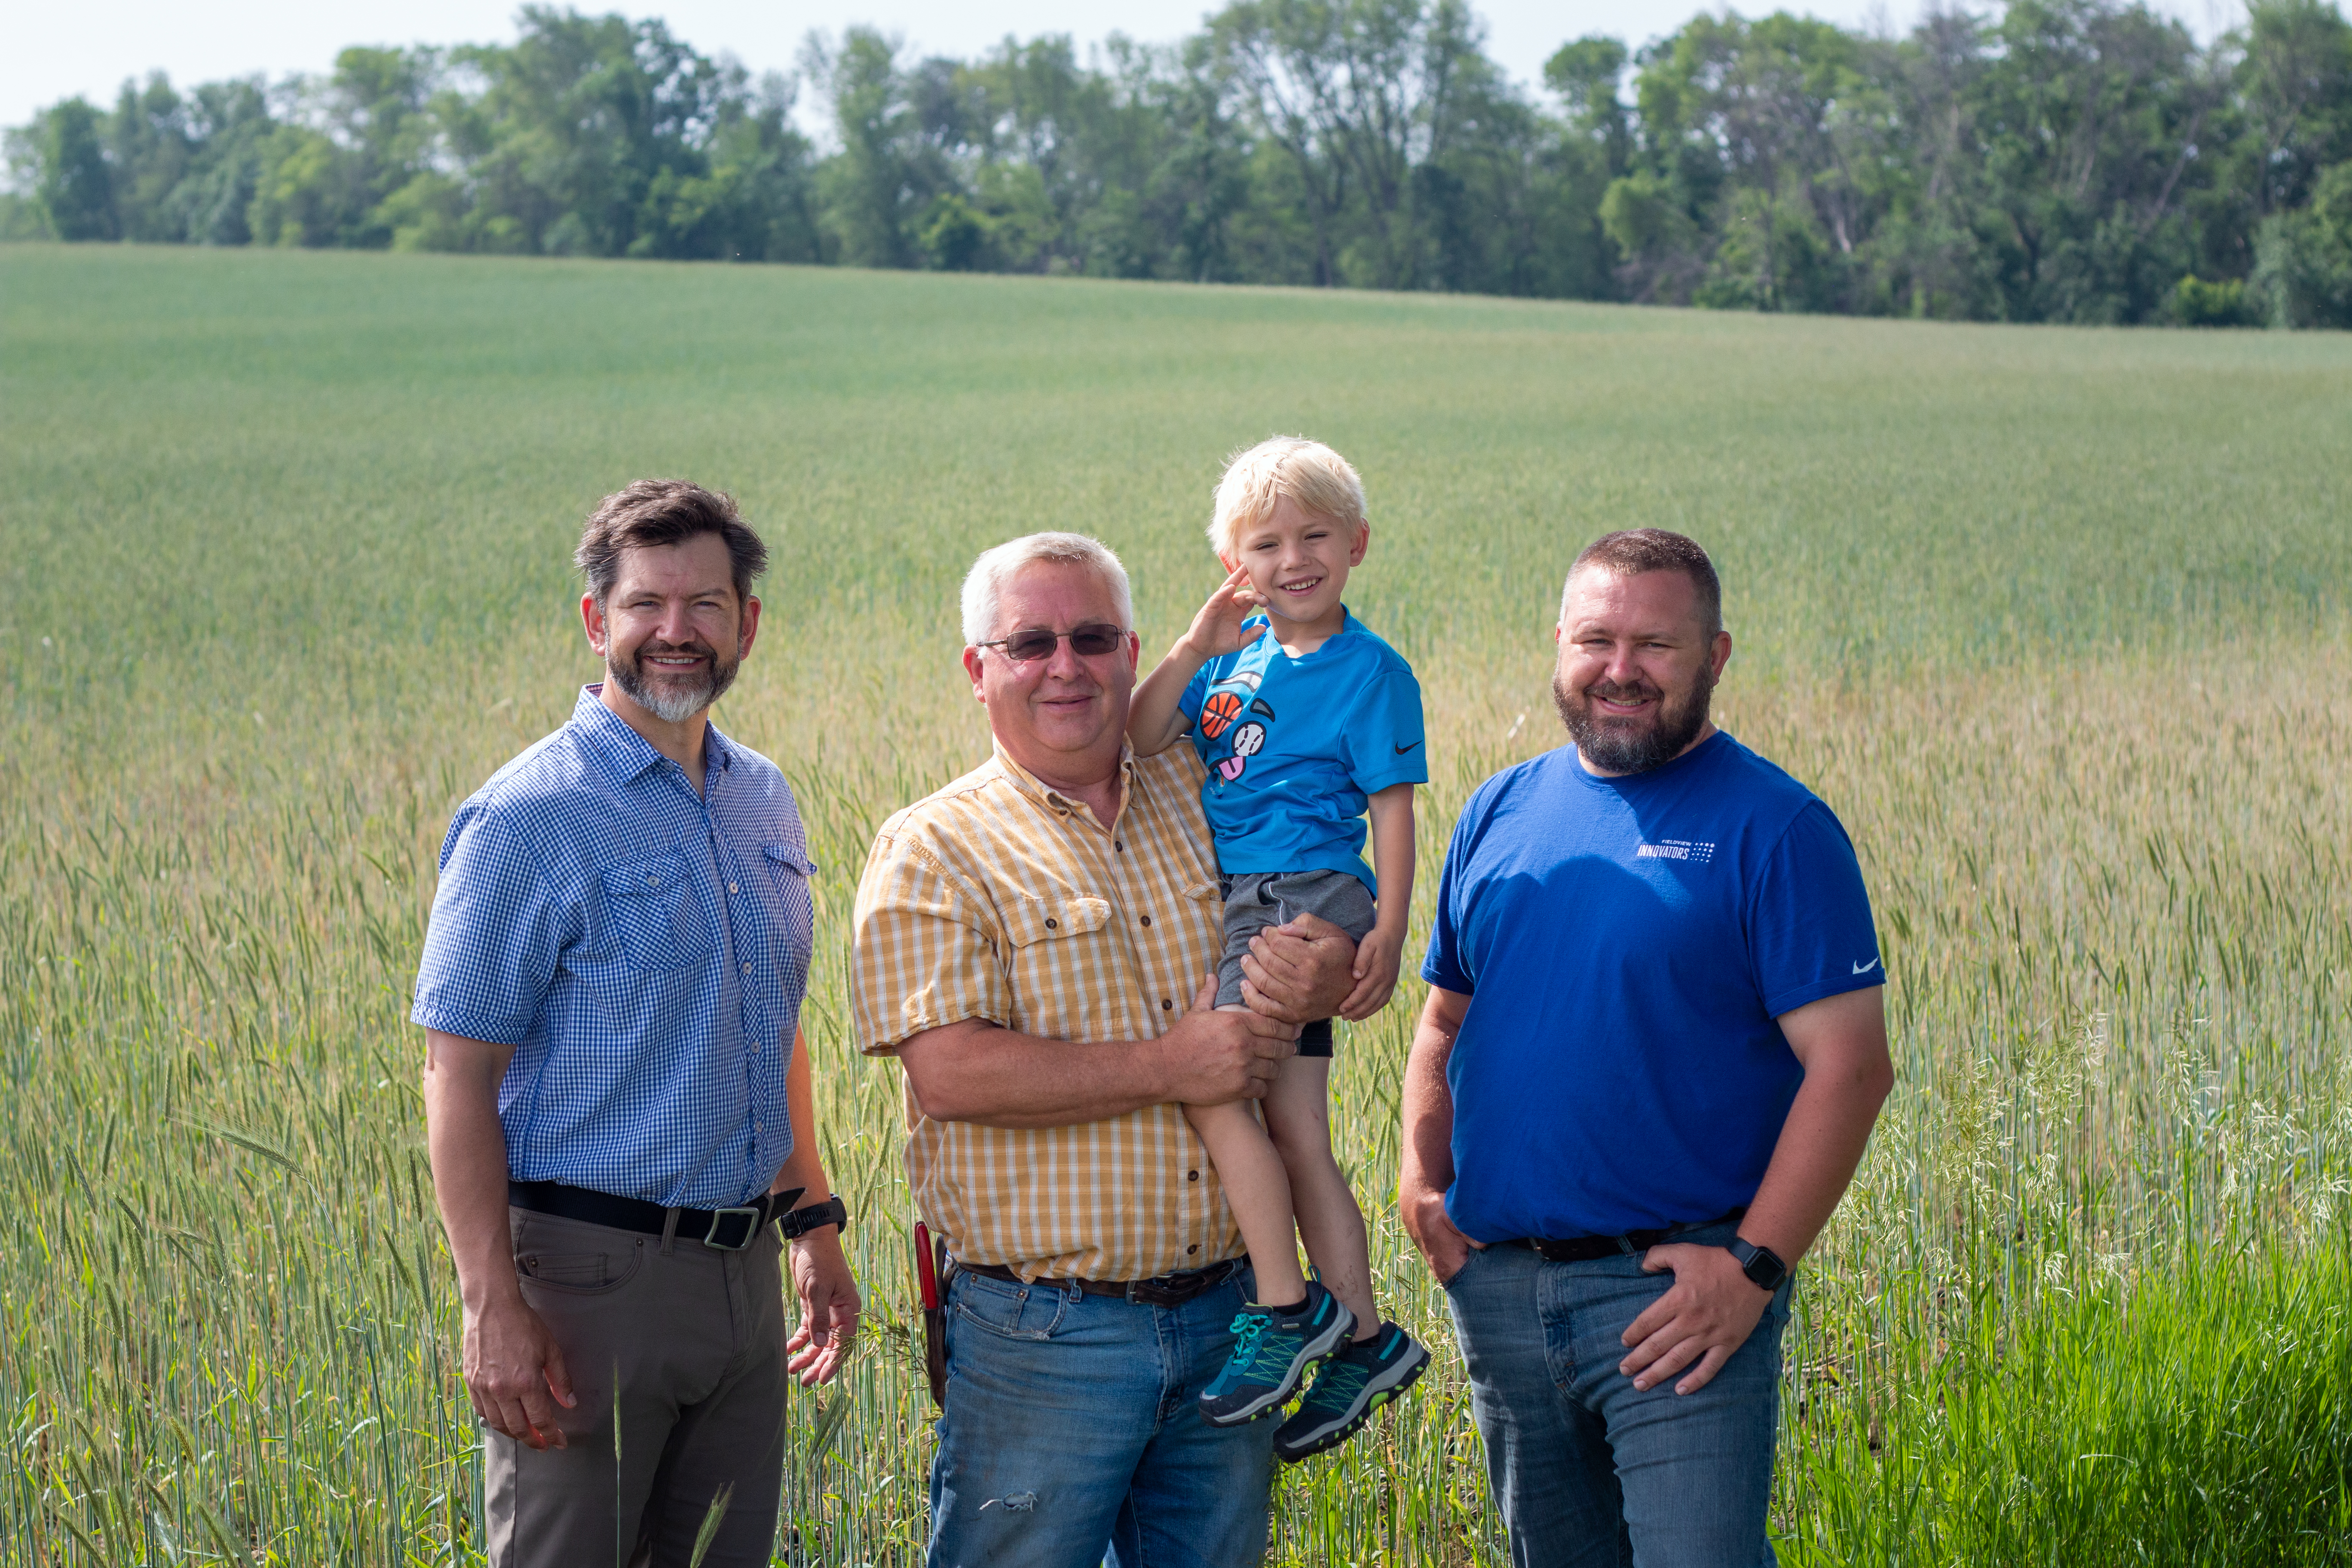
[409,804,564,1046]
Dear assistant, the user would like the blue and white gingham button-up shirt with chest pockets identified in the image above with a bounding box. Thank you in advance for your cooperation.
[409,686,816,1208]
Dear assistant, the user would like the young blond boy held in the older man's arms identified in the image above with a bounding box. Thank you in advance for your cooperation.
[1127,437,1430,1462]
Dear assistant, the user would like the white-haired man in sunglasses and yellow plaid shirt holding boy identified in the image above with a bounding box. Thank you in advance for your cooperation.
[851,534,1355,1568]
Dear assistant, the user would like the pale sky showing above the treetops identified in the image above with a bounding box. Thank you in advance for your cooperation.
[0,0,2244,125]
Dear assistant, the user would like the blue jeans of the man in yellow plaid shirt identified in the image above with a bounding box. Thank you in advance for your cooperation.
[929,1269,1275,1568]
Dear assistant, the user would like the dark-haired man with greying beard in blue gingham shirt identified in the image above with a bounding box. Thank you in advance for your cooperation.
[412,480,858,1568]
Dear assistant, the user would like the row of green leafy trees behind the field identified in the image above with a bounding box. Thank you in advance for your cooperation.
[0,0,2352,327]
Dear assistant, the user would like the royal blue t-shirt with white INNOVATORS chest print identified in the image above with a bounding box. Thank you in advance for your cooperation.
[1421,733,1886,1241]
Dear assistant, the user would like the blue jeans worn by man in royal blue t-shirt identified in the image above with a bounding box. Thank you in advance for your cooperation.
[1446,1222,1790,1568]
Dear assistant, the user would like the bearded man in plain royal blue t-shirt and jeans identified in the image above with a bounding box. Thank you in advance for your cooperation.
[1400,529,1893,1568]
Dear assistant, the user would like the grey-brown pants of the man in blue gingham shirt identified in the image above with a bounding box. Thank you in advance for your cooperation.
[482,1208,786,1568]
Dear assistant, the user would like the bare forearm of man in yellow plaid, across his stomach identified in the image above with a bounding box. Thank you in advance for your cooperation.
[898,1020,1176,1128]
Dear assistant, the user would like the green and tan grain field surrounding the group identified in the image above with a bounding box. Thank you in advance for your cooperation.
[0,247,2352,1568]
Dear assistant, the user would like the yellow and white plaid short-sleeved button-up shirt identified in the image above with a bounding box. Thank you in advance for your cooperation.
[849,745,1242,1279]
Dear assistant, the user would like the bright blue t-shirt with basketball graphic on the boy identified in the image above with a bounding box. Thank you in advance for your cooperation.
[1178,616,1430,896]
